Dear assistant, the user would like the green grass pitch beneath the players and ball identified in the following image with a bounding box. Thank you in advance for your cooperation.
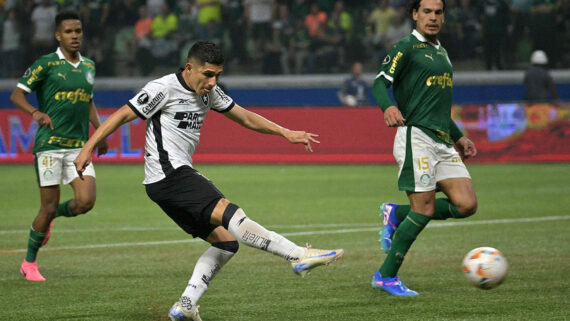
[0,164,570,321]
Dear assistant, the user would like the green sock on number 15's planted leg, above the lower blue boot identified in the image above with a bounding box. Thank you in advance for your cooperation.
[380,211,430,278]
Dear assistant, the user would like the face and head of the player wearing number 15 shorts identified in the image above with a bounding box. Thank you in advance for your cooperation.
[412,0,444,40]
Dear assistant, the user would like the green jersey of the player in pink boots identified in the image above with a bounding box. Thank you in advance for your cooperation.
[18,48,95,153]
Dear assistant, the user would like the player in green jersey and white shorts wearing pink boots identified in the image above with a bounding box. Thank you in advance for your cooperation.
[10,11,107,281]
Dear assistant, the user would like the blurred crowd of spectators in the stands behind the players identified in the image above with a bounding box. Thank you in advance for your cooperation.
[0,0,570,78]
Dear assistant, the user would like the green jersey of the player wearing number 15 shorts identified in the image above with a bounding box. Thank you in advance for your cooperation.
[378,30,453,145]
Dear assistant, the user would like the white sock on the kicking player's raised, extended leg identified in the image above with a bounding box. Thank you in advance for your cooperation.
[228,208,305,261]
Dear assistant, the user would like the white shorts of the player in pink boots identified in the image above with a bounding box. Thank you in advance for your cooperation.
[35,148,95,187]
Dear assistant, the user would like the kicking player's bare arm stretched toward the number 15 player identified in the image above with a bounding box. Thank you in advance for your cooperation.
[224,104,320,152]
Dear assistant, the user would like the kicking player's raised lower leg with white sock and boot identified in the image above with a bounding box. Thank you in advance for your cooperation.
[211,199,344,276]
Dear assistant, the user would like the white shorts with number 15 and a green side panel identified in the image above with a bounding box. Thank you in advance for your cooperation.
[394,126,471,192]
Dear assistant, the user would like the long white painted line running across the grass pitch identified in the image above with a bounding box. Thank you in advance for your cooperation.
[4,215,570,253]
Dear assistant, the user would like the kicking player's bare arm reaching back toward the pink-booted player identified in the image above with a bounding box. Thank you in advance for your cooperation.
[73,105,137,179]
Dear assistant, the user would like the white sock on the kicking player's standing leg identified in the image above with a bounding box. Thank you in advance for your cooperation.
[180,246,235,309]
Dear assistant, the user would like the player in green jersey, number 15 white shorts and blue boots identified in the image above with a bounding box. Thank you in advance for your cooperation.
[372,0,477,296]
